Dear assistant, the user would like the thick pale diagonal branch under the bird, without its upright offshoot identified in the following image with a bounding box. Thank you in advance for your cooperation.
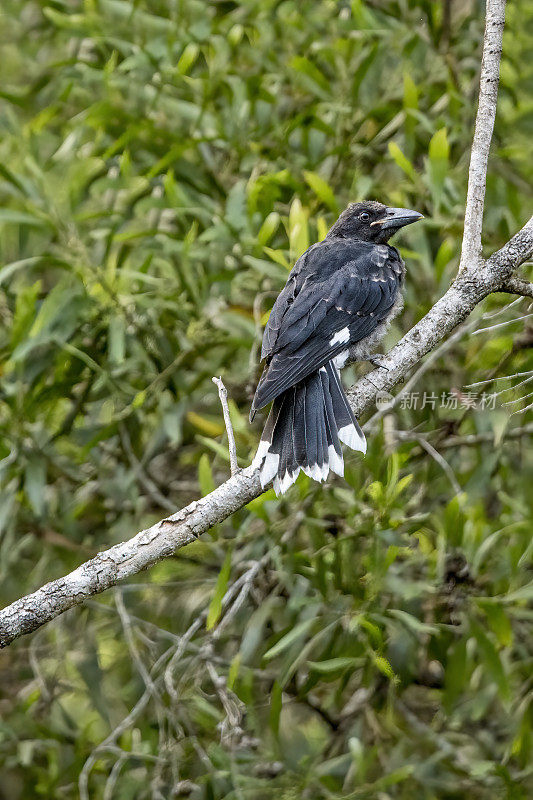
[4,217,533,647]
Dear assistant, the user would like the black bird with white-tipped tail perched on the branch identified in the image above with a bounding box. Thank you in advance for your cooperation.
[250,200,423,495]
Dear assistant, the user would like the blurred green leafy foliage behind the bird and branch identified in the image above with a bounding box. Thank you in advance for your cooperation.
[0,0,533,800]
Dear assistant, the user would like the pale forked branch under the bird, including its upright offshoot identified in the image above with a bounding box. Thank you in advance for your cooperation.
[0,0,533,647]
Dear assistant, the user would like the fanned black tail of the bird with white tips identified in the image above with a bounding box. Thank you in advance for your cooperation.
[252,361,366,495]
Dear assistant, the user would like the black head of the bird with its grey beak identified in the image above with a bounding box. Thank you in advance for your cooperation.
[328,200,423,244]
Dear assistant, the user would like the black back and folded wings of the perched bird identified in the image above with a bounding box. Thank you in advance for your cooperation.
[252,240,401,410]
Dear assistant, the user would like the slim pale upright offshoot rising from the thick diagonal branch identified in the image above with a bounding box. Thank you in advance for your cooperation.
[459,0,505,274]
